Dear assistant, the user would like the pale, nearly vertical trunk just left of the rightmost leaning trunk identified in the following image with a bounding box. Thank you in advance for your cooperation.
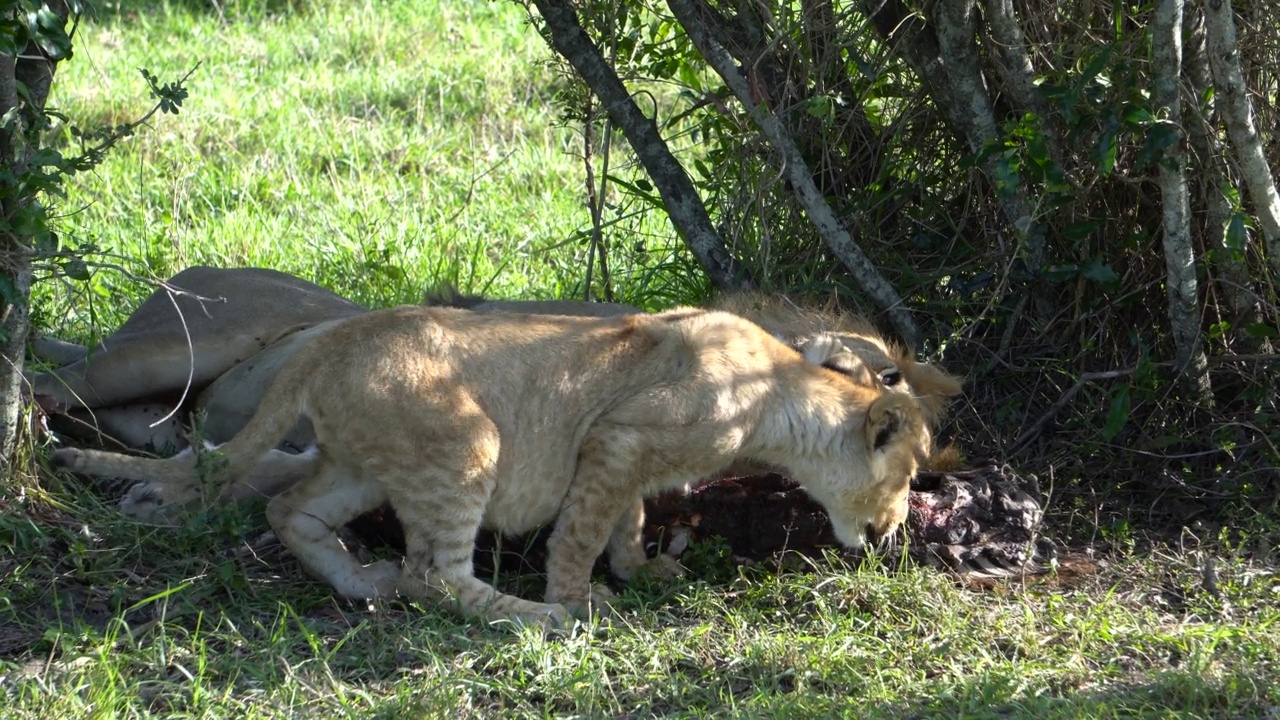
[1151,0,1212,405]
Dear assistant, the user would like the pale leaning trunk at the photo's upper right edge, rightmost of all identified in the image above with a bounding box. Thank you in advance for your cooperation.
[1204,0,1280,274]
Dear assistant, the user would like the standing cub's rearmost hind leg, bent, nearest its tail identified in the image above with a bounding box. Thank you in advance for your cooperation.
[266,450,399,598]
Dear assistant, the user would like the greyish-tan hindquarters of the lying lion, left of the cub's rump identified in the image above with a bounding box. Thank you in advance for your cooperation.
[31,266,367,450]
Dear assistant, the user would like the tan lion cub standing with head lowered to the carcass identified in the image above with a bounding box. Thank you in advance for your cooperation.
[54,306,924,625]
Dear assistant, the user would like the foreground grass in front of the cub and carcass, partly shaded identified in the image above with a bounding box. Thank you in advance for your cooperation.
[0,486,1280,717]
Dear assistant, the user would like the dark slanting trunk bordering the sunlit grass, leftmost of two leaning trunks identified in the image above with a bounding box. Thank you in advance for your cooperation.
[534,0,753,290]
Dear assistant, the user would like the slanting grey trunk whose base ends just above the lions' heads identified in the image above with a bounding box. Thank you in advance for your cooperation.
[667,0,920,345]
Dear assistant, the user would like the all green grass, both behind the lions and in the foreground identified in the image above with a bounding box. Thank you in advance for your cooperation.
[0,0,1280,719]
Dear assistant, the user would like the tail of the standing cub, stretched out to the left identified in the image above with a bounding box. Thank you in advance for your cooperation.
[50,363,306,483]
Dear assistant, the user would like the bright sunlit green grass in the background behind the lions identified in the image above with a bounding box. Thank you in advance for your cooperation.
[41,0,703,331]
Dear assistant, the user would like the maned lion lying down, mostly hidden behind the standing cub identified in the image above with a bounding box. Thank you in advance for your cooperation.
[31,266,961,451]
